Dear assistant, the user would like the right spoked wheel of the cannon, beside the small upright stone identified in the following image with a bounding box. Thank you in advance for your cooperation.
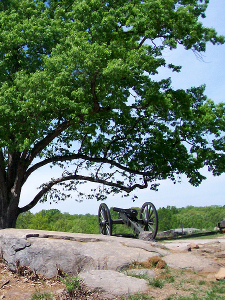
[140,202,158,239]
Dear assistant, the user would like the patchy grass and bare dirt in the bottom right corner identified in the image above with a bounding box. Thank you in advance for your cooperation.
[122,258,225,300]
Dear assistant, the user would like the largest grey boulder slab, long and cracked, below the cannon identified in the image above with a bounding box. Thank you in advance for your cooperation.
[0,229,168,277]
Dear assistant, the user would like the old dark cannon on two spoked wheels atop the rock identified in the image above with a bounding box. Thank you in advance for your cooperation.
[98,202,158,240]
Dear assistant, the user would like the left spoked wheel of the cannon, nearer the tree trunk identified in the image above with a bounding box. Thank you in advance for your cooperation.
[98,203,112,235]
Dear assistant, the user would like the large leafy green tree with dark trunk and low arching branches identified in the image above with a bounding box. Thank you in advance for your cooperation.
[0,0,225,228]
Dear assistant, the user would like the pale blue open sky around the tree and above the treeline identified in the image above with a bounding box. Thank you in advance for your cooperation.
[20,0,225,214]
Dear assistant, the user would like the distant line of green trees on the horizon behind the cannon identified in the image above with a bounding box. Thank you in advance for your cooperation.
[16,206,225,234]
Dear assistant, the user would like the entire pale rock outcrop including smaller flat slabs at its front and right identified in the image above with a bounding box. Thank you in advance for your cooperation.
[0,229,225,298]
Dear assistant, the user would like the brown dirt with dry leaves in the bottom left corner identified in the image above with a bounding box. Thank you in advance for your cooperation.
[0,261,110,300]
